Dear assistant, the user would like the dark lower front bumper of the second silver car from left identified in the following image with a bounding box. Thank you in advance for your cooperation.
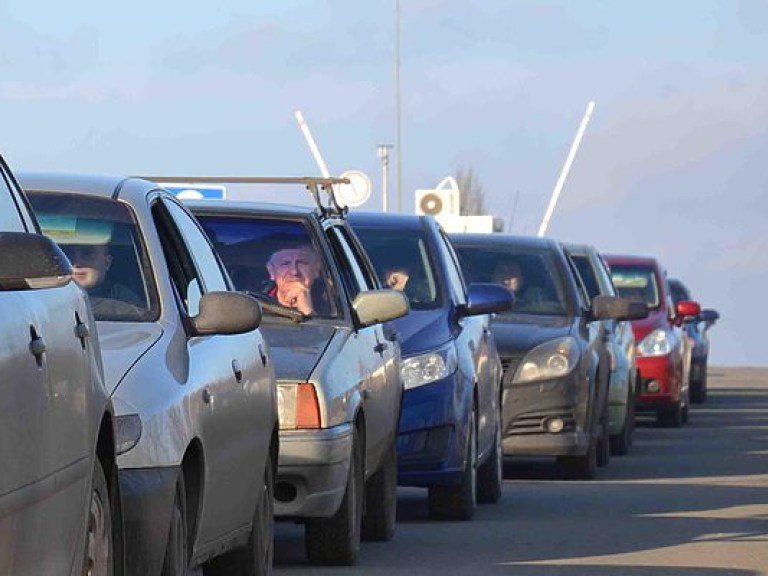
[118,466,179,576]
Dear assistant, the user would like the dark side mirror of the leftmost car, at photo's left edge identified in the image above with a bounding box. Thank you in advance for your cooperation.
[0,232,72,290]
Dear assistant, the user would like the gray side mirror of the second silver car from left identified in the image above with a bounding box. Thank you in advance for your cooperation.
[191,292,261,336]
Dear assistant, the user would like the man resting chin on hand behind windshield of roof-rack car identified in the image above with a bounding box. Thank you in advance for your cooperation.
[267,243,321,316]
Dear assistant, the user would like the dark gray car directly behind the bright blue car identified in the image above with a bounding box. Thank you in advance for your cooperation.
[451,234,630,478]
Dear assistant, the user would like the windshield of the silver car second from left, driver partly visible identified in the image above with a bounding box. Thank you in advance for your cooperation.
[28,191,159,322]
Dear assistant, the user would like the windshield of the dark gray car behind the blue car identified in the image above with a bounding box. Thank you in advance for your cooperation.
[454,243,568,316]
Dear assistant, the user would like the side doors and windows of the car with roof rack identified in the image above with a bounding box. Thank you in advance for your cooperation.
[326,225,402,471]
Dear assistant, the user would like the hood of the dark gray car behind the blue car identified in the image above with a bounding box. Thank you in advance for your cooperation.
[491,314,573,357]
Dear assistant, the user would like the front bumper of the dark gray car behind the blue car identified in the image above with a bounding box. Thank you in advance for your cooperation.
[502,370,590,456]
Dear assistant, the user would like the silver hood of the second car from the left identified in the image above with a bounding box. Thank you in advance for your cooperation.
[97,322,163,395]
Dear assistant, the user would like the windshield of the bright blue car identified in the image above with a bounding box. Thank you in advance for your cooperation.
[355,226,441,310]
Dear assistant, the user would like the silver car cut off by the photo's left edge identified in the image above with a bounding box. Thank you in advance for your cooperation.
[0,157,122,576]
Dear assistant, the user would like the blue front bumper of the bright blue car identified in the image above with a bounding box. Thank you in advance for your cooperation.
[397,372,471,487]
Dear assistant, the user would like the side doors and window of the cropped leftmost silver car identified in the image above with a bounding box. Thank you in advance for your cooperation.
[0,166,93,574]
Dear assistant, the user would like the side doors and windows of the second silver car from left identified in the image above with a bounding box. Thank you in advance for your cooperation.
[153,197,274,547]
